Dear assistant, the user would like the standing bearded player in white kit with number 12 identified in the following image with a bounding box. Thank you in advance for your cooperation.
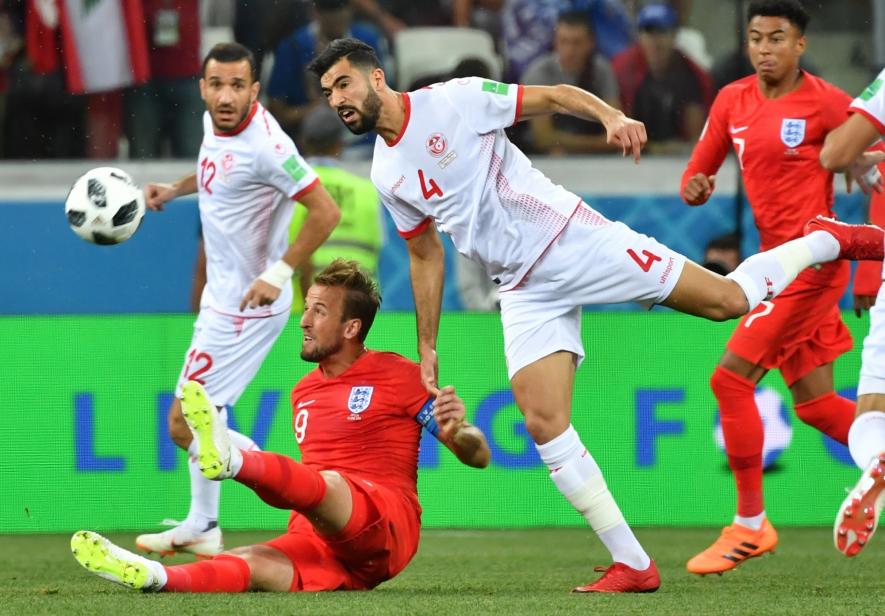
[136,43,340,556]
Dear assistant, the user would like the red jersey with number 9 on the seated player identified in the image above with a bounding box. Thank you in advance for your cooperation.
[292,351,430,504]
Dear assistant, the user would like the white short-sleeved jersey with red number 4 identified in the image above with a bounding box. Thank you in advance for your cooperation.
[372,78,581,291]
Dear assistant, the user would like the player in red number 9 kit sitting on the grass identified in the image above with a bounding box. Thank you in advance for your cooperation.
[71,260,490,592]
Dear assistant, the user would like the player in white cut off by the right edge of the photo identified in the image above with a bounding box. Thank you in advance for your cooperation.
[820,70,885,556]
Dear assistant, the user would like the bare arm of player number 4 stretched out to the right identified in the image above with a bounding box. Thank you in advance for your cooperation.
[520,84,648,163]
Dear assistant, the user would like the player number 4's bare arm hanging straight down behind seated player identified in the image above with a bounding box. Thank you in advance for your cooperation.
[406,224,445,395]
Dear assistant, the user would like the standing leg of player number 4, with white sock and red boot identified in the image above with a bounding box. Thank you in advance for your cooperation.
[511,351,660,592]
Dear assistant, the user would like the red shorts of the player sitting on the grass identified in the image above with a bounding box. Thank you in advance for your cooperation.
[265,473,421,592]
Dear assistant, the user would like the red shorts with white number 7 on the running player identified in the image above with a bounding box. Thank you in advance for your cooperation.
[726,261,853,386]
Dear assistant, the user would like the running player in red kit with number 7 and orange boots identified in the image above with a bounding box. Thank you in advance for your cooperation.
[682,0,872,574]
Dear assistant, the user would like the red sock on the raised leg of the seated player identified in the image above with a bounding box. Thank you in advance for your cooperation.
[235,451,326,511]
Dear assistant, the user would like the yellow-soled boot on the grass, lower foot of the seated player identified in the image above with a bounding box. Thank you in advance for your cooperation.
[71,530,166,590]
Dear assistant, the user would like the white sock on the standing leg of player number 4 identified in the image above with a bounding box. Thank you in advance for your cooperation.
[535,426,651,571]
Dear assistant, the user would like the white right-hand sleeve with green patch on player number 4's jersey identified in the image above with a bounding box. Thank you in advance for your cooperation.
[434,77,522,135]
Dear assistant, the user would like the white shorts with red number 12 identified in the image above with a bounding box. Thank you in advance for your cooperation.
[175,307,289,406]
